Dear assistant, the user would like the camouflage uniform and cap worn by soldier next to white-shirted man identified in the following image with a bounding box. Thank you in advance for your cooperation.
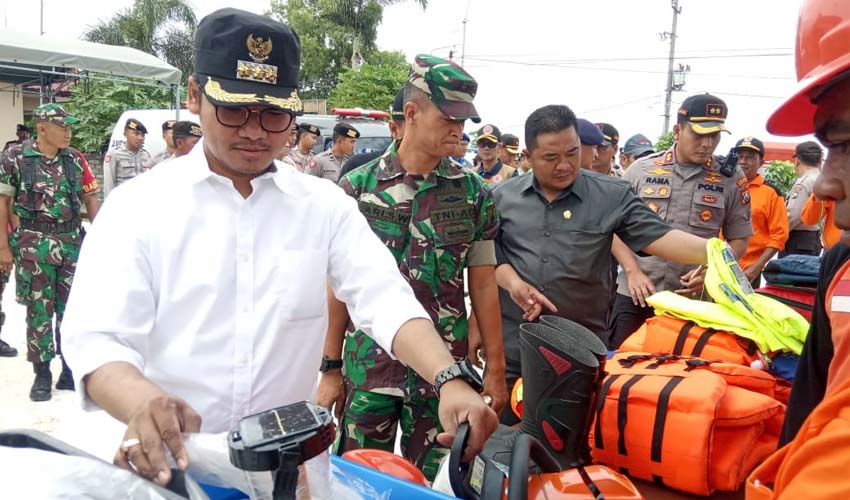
[338,55,490,480]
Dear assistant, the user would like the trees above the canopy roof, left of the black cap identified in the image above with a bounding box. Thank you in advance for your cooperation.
[83,0,197,82]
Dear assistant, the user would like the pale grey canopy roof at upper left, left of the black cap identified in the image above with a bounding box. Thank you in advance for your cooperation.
[0,30,181,84]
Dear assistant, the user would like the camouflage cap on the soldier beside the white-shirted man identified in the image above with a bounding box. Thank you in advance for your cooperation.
[408,54,481,123]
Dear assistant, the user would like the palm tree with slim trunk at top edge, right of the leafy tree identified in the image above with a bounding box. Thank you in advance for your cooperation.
[323,0,428,71]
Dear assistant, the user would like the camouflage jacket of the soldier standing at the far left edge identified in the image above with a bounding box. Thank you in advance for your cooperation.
[0,141,97,265]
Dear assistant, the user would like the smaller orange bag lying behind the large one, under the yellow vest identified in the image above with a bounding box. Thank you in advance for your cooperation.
[619,316,759,366]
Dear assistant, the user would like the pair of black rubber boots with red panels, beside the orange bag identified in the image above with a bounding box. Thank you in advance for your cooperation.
[519,320,607,469]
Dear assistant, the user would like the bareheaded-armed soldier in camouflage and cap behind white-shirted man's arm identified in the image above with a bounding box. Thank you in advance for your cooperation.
[326,55,506,479]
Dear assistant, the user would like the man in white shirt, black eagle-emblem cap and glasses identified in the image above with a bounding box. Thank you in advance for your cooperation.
[63,9,496,484]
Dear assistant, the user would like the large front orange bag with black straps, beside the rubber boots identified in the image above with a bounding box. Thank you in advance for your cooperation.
[590,353,785,496]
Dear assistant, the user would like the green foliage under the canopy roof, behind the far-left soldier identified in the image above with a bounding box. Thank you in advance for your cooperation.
[65,79,172,153]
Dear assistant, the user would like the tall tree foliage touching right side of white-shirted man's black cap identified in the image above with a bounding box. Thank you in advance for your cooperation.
[267,0,428,99]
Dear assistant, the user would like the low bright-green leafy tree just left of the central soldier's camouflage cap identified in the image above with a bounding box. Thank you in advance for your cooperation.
[328,52,410,111]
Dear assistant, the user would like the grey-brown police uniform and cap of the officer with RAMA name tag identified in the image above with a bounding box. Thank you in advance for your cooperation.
[611,94,753,348]
